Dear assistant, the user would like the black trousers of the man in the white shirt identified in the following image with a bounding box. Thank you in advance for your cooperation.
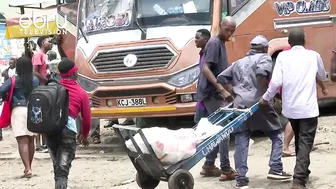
[289,117,318,186]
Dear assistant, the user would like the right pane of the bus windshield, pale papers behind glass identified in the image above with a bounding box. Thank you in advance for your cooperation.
[137,0,211,28]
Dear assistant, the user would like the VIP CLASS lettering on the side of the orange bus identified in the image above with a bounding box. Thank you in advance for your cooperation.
[274,0,331,16]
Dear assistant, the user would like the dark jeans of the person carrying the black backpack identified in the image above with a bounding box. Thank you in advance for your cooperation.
[46,128,76,189]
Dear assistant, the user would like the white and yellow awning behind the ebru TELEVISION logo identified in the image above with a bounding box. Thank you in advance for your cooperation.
[6,8,59,39]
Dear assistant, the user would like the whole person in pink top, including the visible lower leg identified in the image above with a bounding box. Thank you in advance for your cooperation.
[32,36,52,153]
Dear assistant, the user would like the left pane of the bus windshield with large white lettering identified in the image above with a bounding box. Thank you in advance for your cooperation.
[80,0,134,35]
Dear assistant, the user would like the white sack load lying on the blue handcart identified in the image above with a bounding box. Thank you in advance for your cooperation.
[126,127,197,165]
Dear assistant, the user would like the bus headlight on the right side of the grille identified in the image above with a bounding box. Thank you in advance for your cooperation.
[168,64,200,87]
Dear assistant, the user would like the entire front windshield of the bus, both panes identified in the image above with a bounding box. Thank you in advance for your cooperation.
[80,0,212,35]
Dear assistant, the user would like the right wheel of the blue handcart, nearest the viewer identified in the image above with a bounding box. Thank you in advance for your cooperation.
[168,169,194,189]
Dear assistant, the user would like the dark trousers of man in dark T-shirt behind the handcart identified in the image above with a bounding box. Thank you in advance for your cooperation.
[203,96,231,171]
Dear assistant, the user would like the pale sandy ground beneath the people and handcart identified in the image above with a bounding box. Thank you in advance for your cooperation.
[0,116,336,189]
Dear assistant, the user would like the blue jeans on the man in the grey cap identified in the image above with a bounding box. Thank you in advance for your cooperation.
[234,130,283,182]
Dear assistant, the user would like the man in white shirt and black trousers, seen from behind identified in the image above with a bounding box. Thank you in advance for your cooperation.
[260,28,326,189]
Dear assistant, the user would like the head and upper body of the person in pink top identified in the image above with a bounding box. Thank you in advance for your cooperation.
[32,36,52,84]
